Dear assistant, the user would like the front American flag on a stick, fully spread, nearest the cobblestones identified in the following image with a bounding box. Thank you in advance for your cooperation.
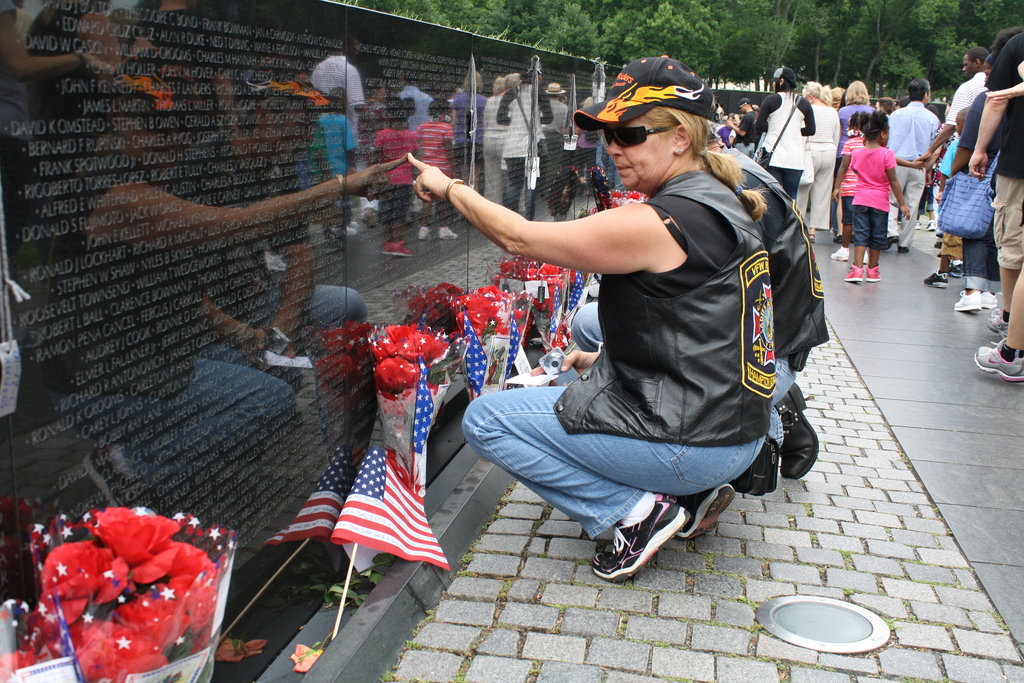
[331,446,450,569]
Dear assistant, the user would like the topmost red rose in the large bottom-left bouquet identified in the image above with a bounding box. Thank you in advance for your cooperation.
[88,508,181,584]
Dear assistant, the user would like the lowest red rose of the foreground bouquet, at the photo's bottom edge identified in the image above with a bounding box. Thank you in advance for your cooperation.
[75,622,168,683]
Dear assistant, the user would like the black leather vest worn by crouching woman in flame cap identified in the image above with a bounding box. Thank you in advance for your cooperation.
[555,171,775,445]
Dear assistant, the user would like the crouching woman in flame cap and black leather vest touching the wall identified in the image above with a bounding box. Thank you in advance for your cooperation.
[405,57,774,582]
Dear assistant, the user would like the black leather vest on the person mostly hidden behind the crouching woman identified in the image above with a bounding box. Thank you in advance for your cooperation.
[725,150,828,371]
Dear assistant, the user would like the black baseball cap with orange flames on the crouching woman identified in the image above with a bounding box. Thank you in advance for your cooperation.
[572,56,714,130]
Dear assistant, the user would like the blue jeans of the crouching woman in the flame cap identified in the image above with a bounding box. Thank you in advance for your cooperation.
[462,387,763,538]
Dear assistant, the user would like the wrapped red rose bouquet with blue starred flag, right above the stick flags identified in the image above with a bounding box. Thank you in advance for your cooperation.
[371,325,463,495]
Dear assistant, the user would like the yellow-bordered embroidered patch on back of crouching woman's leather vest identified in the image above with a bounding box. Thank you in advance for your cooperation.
[739,251,775,398]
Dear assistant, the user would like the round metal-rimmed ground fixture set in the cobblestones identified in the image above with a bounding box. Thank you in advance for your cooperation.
[757,595,889,654]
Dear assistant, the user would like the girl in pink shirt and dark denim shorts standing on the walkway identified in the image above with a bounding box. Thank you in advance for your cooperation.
[845,111,910,284]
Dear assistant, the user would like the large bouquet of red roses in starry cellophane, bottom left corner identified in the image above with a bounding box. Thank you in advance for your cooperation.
[0,508,236,683]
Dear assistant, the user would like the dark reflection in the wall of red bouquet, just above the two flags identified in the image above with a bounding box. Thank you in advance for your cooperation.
[307,322,377,455]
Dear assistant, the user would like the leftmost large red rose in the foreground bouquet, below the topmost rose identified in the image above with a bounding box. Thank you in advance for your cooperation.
[41,541,129,624]
